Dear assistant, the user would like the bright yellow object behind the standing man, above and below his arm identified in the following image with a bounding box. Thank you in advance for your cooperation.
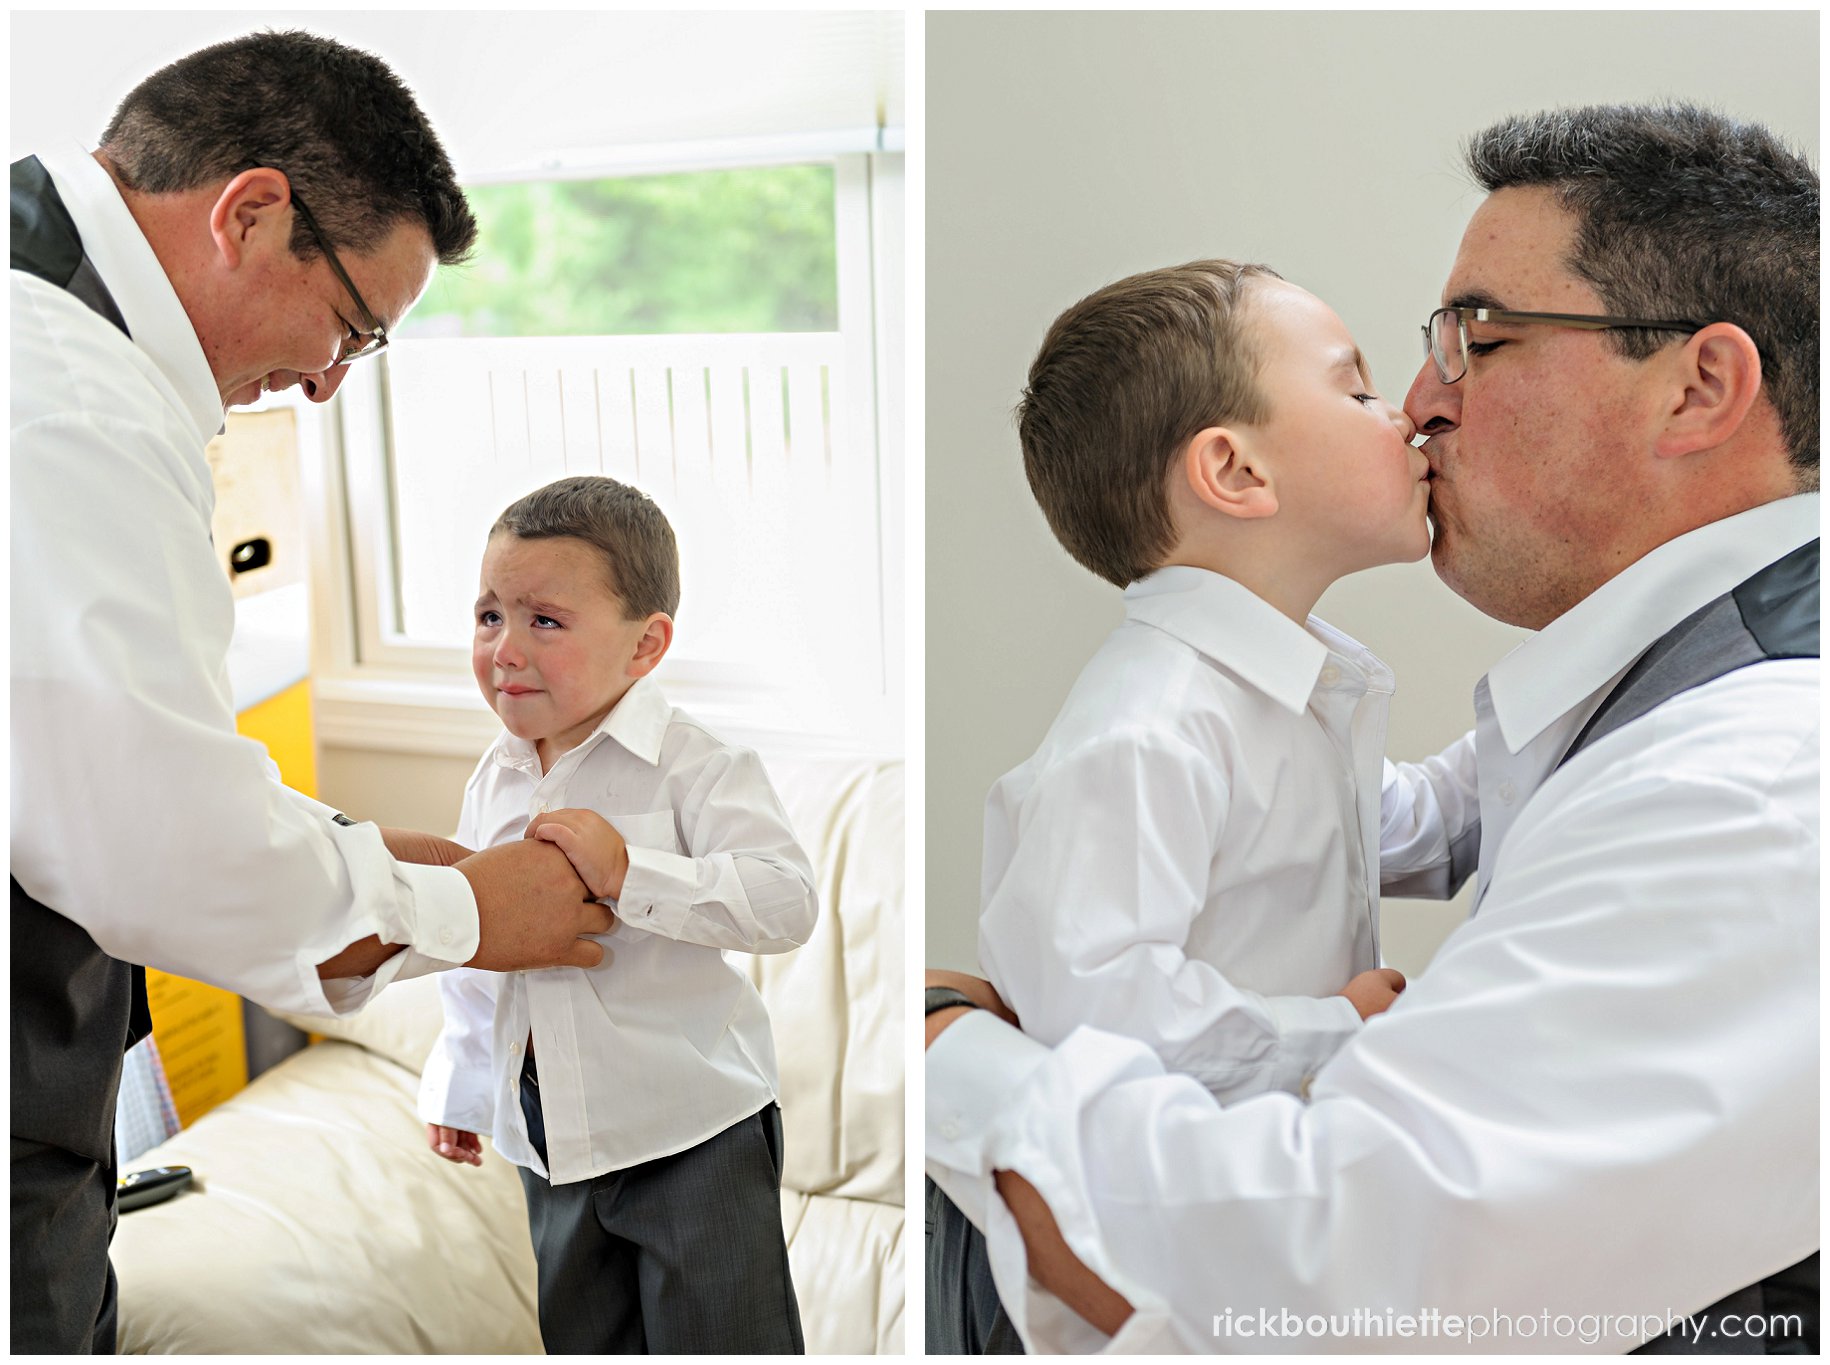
[146,683,318,1127]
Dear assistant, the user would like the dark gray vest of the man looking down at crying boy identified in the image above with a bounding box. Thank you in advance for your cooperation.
[11,157,152,1167]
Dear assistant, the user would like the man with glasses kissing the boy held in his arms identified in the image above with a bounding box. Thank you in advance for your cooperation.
[928,106,1819,1352]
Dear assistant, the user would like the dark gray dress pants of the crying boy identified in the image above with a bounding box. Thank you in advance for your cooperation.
[522,1058,805,1356]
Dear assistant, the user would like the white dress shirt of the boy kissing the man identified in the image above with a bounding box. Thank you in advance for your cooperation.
[979,565,1442,1100]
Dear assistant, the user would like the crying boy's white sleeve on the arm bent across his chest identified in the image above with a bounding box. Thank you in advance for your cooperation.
[609,748,818,953]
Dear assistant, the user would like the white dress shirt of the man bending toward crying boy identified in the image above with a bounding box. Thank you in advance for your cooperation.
[11,148,478,1014]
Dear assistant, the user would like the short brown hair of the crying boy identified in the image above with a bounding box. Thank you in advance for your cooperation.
[489,474,681,620]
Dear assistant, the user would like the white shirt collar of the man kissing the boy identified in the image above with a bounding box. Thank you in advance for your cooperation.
[1486,492,1817,754]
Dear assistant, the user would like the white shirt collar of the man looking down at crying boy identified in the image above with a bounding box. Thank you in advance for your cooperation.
[38,143,223,441]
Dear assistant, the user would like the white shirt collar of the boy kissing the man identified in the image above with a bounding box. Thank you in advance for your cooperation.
[1125,564,1351,712]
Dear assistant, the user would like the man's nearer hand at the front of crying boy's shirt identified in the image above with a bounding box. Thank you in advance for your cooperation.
[456,840,617,972]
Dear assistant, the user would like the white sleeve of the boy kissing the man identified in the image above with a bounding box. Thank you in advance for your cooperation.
[979,732,1360,1100]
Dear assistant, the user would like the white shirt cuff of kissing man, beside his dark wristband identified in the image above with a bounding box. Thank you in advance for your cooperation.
[926,1010,1049,1175]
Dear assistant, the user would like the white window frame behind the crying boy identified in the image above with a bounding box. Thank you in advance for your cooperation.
[300,150,906,756]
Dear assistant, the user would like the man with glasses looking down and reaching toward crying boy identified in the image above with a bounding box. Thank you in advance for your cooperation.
[11,33,611,1352]
